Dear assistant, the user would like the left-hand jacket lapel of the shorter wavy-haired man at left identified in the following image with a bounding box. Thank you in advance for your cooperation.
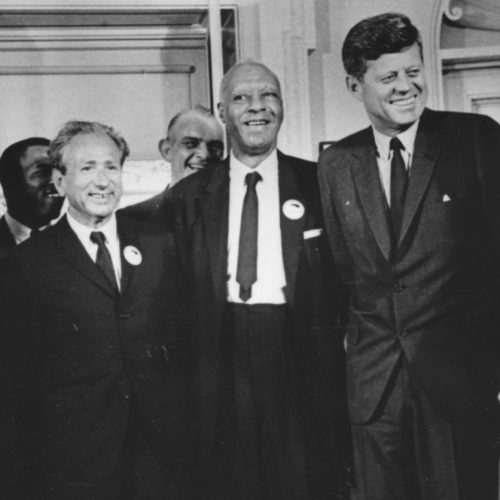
[55,216,115,297]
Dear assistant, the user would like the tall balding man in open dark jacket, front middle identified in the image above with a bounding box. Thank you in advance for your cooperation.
[172,61,346,500]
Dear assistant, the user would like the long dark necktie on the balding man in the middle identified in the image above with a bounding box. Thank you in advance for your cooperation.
[236,172,262,302]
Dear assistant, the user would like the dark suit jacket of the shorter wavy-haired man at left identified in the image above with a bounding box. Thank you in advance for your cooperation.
[1,214,193,500]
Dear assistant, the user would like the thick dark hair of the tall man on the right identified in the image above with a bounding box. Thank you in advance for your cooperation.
[342,12,423,80]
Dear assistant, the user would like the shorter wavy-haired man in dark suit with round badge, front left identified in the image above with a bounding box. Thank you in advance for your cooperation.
[2,122,197,500]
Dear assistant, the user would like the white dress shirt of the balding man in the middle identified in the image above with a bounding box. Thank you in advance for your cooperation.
[227,150,286,304]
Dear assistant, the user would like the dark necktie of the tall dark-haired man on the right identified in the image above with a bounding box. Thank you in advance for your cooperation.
[390,137,408,243]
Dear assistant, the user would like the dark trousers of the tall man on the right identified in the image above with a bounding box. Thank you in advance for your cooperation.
[352,359,498,500]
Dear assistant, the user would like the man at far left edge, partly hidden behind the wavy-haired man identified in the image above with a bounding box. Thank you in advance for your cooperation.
[0,137,63,259]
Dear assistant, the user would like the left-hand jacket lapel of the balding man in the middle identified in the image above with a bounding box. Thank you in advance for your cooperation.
[200,159,229,303]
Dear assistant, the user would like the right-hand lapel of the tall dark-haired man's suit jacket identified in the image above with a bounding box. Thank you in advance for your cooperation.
[398,110,439,245]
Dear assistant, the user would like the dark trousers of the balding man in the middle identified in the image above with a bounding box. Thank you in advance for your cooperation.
[206,304,335,500]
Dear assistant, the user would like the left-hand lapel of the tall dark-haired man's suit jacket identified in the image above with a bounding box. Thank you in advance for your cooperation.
[351,128,391,260]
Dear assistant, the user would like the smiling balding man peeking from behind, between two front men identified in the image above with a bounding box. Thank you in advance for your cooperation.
[123,106,224,225]
